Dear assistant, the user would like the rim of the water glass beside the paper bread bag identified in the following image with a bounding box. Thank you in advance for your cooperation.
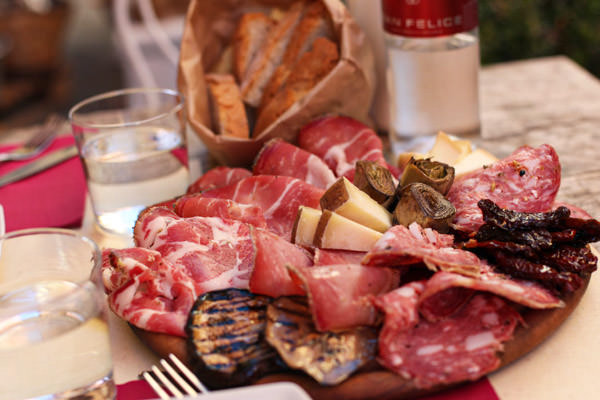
[68,88,185,129]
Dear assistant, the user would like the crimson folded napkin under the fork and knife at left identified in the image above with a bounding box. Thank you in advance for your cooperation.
[0,136,86,232]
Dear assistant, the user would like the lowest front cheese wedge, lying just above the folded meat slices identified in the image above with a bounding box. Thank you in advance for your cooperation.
[314,210,383,251]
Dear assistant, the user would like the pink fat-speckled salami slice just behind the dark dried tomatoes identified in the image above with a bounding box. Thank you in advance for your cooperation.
[447,145,561,232]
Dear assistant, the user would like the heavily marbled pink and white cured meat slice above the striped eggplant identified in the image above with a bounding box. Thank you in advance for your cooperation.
[134,208,255,293]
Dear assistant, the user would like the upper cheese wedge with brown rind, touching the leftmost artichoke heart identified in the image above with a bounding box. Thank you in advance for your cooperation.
[321,177,392,232]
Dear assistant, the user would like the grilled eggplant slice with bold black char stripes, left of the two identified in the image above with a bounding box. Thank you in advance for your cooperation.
[186,289,284,388]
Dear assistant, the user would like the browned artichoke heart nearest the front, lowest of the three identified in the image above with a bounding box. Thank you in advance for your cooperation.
[394,183,456,232]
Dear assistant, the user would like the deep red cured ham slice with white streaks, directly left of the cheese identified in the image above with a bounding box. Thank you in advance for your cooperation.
[202,175,324,241]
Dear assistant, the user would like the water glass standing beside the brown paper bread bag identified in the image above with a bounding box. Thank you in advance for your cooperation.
[69,88,190,235]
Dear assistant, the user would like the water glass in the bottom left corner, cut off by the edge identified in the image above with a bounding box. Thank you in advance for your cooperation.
[0,228,116,400]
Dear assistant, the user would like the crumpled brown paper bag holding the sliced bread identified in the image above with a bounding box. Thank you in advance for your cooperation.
[178,0,375,166]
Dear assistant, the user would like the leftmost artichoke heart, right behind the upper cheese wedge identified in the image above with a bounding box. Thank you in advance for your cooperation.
[354,160,396,210]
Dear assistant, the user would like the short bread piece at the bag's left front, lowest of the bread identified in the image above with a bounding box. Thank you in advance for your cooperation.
[206,74,250,139]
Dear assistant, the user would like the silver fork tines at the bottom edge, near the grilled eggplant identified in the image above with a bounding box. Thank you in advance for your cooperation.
[142,354,208,400]
